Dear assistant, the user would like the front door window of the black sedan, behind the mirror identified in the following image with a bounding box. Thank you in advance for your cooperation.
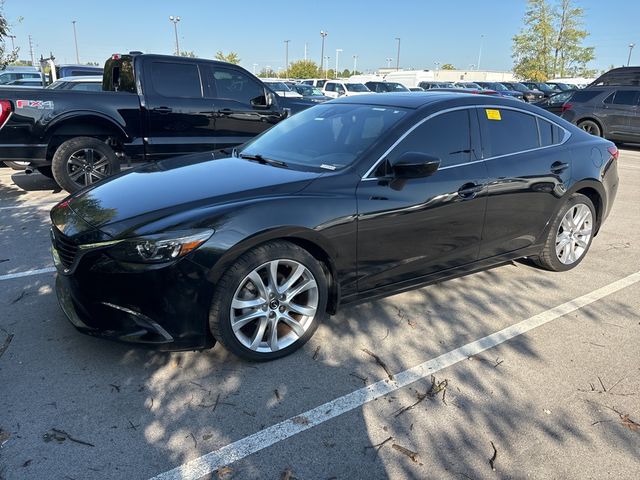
[388,110,471,167]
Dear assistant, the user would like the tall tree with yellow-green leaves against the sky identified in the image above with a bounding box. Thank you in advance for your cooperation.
[512,0,595,82]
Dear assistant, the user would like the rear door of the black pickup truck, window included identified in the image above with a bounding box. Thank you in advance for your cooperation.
[144,59,215,160]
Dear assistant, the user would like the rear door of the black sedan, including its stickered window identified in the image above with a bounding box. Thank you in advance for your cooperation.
[478,107,571,259]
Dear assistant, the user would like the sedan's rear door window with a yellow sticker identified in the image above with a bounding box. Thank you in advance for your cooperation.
[479,108,540,157]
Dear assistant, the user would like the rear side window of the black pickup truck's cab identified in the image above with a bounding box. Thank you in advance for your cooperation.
[151,62,202,98]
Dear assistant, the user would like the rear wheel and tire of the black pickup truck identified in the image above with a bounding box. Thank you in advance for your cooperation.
[51,137,120,193]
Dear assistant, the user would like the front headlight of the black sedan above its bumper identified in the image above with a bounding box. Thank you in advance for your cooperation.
[108,229,214,263]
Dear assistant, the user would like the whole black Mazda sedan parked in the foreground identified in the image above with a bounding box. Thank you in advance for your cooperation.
[51,92,618,360]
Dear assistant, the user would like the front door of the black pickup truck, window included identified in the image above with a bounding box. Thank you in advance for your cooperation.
[201,64,283,150]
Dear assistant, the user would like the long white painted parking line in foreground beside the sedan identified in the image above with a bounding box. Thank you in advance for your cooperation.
[152,272,640,480]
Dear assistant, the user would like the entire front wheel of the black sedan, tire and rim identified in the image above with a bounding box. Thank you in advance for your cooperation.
[209,241,328,362]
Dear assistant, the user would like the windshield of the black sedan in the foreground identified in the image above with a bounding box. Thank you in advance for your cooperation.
[241,103,407,170]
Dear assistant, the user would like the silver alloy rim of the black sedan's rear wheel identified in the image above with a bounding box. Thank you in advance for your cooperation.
[556,203,593,265]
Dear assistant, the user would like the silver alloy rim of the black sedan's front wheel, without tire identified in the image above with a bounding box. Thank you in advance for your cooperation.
[230,259,319,353]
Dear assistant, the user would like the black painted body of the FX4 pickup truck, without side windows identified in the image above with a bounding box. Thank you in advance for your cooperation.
[0,55,302,166]
